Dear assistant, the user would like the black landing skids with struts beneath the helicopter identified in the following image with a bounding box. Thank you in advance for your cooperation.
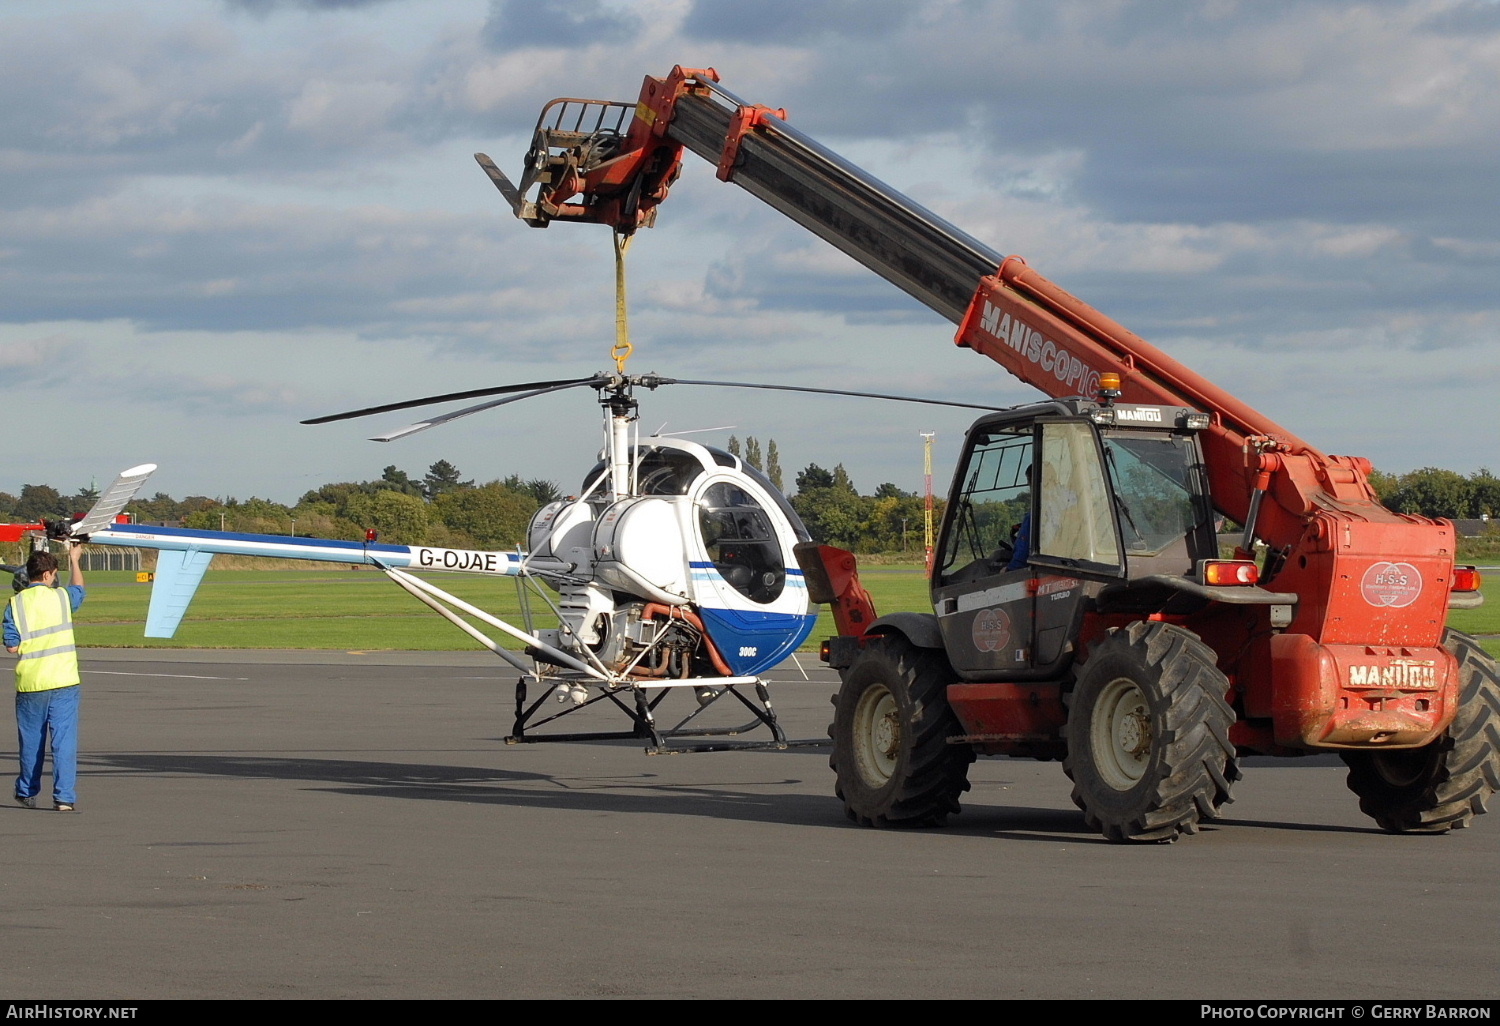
[506,677,831,755]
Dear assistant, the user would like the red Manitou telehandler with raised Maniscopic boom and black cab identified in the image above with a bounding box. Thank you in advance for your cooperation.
[476,68,1500,842]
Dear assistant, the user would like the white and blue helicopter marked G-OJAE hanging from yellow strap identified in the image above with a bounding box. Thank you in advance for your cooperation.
[74,372,995,755]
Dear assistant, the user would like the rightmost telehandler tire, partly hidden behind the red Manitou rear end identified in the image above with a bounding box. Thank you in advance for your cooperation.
[1340,630,1500,834]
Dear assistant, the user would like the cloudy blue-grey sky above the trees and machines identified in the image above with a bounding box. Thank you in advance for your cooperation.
[0,0,1500,501]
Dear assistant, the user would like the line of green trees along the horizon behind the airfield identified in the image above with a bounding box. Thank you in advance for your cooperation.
[0,459,1500,555]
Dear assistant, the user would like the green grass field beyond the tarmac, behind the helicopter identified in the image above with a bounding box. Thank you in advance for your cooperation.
[78,564,1500,656]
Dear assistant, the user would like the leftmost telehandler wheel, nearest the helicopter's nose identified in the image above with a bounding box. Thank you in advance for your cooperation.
[828,636,974,827]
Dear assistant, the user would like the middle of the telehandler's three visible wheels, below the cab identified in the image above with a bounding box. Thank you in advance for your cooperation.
[1062,621,1241,843]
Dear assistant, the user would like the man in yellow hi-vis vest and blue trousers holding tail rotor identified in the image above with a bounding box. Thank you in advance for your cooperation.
[0,546,84,812]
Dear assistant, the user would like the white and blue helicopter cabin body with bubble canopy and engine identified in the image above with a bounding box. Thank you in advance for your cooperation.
[528,438,818,677]
